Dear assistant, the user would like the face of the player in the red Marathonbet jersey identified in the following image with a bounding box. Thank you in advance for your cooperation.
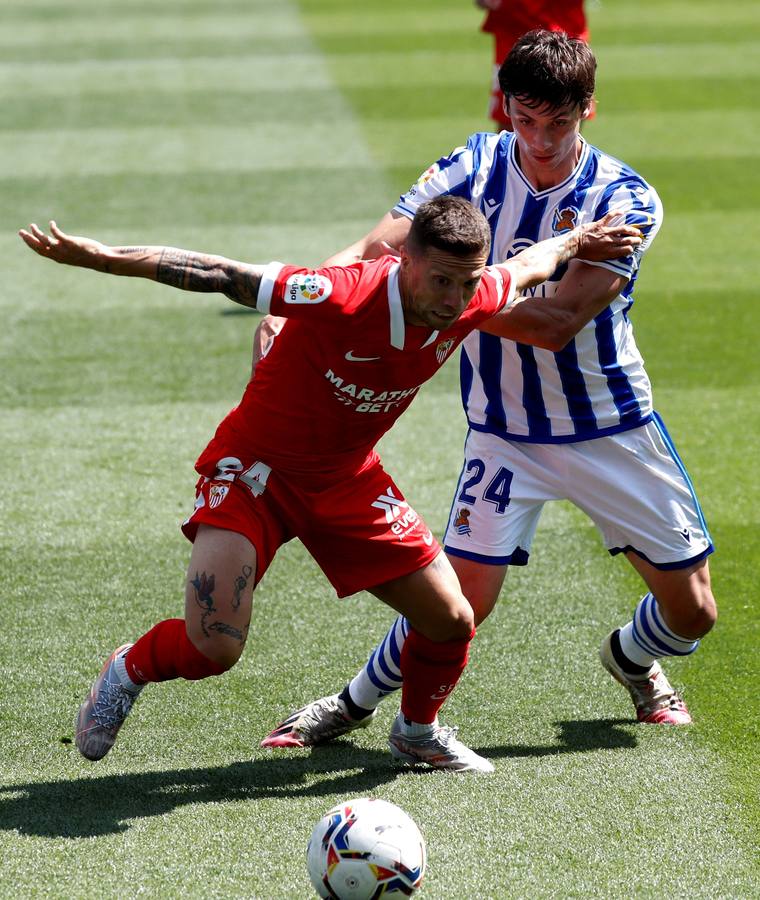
[401,247,487,331]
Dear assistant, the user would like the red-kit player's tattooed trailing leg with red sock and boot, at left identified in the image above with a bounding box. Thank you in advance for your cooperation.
[76,526,256,760]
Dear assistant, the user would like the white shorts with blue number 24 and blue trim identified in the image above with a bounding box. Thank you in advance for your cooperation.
[444,414,713,569]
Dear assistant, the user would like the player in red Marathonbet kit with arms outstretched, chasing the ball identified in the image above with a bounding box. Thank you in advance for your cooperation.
[20,196,640,772]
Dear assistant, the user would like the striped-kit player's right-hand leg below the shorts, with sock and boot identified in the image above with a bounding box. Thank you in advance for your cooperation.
[600,553,717,725]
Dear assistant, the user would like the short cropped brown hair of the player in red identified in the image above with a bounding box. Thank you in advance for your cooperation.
[406,194,491,256]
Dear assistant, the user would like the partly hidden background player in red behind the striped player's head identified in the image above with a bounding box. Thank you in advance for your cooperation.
[475,0,593,131]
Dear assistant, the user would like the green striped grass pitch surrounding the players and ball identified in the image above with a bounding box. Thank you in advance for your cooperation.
[0,0,760,900]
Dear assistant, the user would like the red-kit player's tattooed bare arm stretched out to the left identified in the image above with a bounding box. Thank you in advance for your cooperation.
[19,222,264,307]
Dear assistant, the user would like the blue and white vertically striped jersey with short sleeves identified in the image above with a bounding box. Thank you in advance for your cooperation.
[395,131,662,443]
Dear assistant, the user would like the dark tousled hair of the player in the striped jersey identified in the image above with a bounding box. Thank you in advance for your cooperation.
[499,28,596,109]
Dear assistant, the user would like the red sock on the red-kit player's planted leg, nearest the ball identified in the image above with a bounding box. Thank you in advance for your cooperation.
[400,628,475,723]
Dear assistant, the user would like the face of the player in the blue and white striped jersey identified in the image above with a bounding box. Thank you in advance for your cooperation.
[504,97,588,189]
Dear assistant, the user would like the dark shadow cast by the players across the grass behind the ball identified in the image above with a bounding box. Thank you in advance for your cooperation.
[0,719,636,838]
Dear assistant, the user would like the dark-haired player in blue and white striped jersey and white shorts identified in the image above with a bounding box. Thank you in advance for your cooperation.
[264,30,716,746]
